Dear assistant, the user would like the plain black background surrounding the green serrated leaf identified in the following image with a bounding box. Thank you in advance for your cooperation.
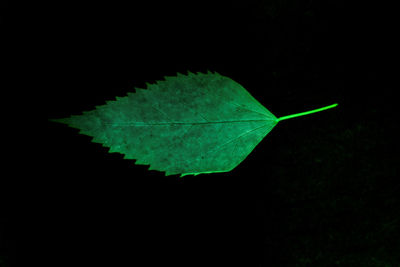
[0,0,400,267]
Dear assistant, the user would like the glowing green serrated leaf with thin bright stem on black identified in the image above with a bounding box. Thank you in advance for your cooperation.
[53,72,337,176]
